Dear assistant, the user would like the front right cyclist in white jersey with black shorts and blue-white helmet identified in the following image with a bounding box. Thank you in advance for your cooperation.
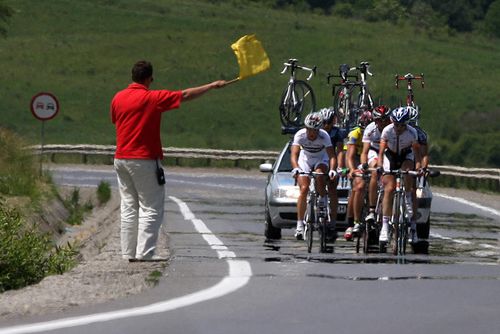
[377,107,420,242]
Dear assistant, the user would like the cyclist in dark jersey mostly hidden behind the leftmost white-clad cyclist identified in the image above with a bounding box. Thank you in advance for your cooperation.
[320,107,347,240]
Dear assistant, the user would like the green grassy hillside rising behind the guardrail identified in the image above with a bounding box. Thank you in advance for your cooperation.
[0,0,500,166]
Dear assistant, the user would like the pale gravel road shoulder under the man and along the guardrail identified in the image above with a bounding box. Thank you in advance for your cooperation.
[0,169,500,321]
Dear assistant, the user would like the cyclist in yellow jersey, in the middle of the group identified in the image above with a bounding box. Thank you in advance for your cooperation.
[344,110,372,241]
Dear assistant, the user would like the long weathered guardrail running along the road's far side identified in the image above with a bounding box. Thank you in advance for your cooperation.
[29,144,500,184]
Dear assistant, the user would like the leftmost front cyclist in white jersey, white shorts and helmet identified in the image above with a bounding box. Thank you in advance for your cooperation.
[290,112,337,240]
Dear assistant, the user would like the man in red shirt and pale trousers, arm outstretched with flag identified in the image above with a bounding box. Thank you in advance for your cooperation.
[111,60,227,261]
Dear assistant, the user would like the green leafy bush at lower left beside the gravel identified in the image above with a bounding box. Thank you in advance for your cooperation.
[0,201,77,292]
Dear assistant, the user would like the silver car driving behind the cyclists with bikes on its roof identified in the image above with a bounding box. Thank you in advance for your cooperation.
[260,141,350,239]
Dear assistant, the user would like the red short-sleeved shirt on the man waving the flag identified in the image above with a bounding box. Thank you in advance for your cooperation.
[111,83,182,159]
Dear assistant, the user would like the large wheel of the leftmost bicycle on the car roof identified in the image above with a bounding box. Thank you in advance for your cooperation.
[279,80,316,127]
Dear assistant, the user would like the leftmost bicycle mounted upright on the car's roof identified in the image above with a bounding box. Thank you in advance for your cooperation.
[279,59,316,127]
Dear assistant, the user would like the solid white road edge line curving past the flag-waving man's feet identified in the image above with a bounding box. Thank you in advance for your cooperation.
[0,196,252,334]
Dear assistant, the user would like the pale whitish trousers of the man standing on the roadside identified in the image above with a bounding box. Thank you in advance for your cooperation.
[114,159,165,259]
